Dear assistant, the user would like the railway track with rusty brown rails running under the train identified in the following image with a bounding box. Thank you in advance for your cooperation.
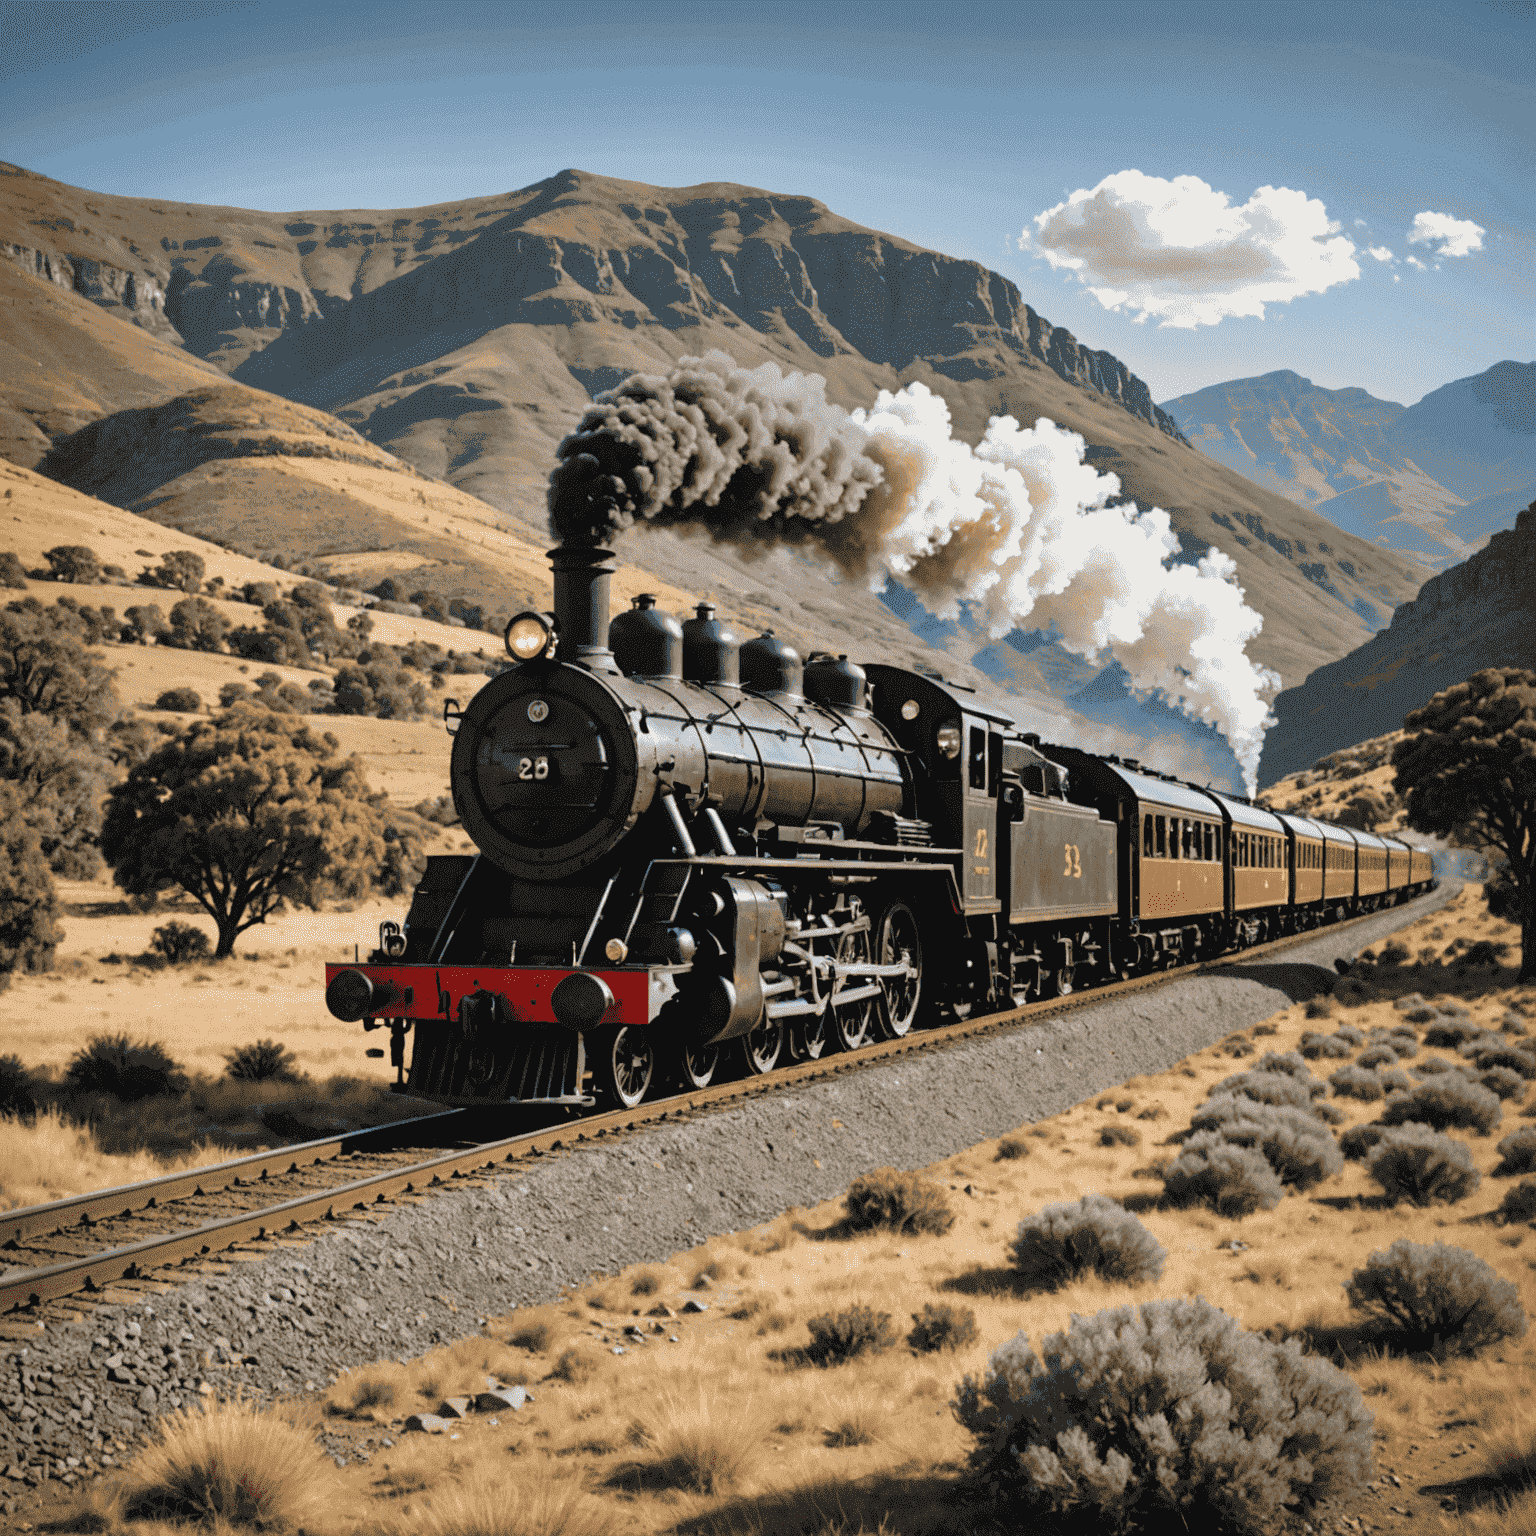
[0,897,1433,1321]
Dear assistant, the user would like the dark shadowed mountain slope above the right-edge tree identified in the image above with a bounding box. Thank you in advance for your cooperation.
[1260,502,1536,785]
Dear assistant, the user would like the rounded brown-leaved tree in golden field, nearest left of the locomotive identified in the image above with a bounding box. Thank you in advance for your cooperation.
[101,703,384,958]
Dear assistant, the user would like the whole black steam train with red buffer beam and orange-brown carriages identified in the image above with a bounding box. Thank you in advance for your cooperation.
[326,547,1433,1107]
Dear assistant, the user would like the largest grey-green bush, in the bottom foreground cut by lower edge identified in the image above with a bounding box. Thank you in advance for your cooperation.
[952,1298,1373,1536]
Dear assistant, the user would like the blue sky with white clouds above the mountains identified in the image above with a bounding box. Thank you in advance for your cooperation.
[0,0,1536,402]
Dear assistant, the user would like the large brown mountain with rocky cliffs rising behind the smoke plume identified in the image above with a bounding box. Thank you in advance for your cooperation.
[0,166,1421,682]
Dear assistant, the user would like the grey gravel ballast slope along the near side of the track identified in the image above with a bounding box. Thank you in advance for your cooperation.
[0,888,1455,1486]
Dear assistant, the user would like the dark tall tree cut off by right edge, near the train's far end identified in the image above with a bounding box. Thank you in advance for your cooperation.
[1392,667,1536,982]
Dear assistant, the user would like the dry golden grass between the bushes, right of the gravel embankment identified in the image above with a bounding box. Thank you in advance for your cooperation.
[21,888,1536,1536]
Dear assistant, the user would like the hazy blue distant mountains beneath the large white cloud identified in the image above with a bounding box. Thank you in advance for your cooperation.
[1163,362,1536,568]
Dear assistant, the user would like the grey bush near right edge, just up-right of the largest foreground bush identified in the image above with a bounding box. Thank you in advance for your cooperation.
[1344,1238,1525,1355]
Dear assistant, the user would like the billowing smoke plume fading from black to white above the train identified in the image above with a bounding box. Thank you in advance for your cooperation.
[550,352,1279,793]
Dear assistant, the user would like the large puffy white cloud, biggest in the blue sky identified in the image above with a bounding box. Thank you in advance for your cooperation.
[1018,170,1359,330]
